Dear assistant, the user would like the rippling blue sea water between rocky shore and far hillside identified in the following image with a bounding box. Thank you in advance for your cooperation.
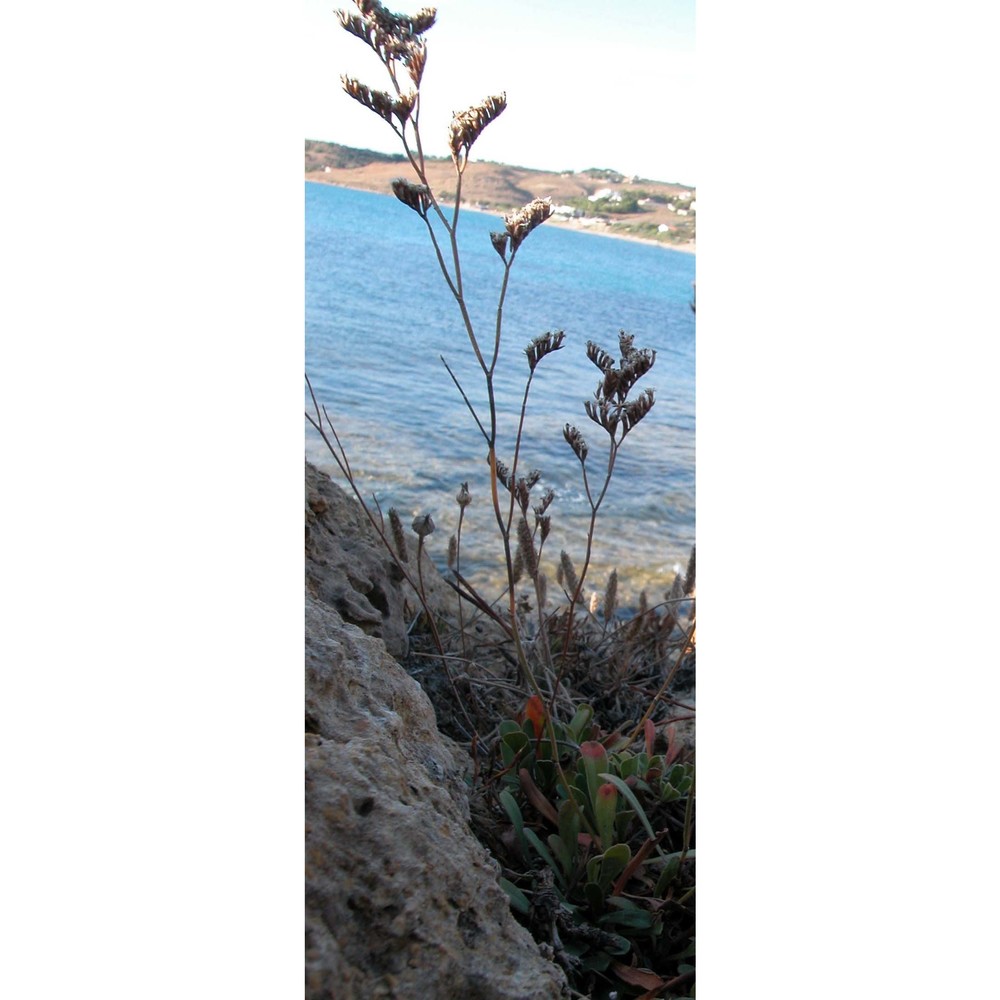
[305,183,695,600]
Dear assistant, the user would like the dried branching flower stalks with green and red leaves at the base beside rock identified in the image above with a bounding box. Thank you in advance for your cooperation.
[307,0,694,981]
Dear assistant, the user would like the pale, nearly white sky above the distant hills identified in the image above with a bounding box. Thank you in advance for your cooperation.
[302,0,698,185]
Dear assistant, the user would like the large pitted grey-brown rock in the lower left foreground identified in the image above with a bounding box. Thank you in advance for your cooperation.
[306,592,565,1000]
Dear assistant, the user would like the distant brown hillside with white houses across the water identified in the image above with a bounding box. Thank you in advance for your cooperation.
[305,139,696,248]
